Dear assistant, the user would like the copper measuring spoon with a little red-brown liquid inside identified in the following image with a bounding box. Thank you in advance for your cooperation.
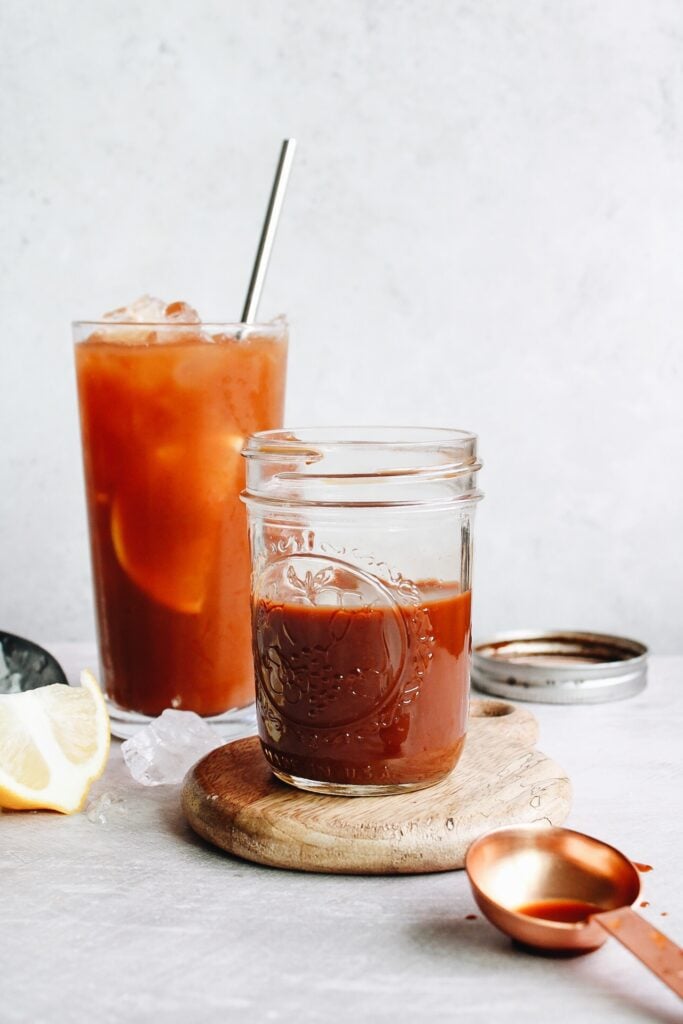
[465,825,683,997]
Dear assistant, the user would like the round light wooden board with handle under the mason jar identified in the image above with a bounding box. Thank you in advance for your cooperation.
[182,700,571,874]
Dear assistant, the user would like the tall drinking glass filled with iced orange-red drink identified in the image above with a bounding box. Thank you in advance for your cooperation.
[74,322,288,723]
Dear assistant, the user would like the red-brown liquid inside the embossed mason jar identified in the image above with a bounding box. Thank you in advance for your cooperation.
[254,583,470,784]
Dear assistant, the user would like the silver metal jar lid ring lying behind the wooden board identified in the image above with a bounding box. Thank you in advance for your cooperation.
[472,630,647,703]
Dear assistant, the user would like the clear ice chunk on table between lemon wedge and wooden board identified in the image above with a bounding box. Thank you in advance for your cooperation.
[121,708,224,785]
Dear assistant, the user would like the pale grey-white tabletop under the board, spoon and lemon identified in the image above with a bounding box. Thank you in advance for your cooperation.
[0,643,683,1024]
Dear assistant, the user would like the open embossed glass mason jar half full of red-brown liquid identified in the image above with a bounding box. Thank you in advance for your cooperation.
[243,427,481,796]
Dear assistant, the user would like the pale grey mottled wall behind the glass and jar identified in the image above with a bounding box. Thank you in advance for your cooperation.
[0,0,683,653]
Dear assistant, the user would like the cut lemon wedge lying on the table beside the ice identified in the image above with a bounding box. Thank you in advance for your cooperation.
[0,670,110,814]
